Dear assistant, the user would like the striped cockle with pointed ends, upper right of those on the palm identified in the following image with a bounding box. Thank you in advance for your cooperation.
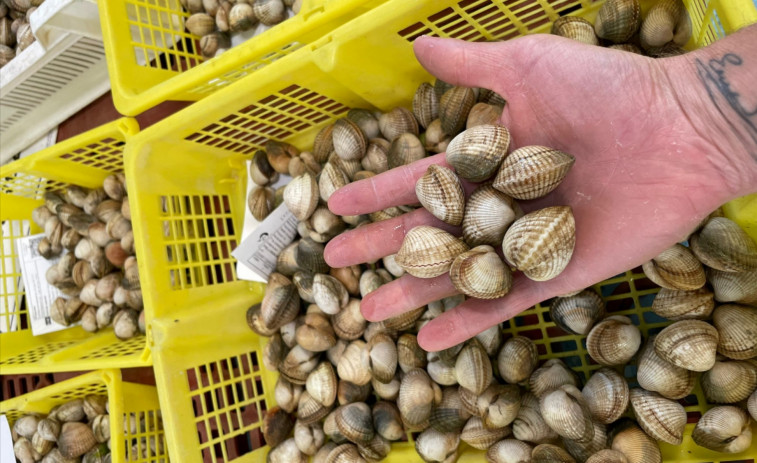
[493,146,576,199]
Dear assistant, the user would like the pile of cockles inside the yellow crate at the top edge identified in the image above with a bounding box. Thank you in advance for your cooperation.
[181,0,302,58]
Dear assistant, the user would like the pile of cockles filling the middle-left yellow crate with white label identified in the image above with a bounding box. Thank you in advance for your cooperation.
[32,174,145,339]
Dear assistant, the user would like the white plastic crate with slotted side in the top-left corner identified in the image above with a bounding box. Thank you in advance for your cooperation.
[0,0,110,164]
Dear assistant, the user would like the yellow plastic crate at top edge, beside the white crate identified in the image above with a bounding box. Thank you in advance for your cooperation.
[99,0,386,116]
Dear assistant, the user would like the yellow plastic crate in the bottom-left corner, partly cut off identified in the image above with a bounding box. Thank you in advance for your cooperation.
[0,370,168,463]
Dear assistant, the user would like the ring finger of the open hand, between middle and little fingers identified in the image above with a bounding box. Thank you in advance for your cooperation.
[360,273,457,322]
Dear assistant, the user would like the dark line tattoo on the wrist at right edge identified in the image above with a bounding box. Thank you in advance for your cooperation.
[697,53,757,149]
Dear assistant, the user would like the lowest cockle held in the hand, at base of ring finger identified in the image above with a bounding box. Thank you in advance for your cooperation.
[449,245,513,299]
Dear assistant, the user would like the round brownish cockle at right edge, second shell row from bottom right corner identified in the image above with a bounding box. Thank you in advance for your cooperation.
[701,360,757,404]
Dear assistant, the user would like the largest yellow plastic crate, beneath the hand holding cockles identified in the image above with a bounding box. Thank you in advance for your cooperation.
[126,0,757,463]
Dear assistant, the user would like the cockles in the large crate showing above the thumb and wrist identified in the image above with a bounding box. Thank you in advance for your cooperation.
[552,0,691,58]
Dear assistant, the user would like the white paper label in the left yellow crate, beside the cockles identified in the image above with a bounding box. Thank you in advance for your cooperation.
[16,233,69,336]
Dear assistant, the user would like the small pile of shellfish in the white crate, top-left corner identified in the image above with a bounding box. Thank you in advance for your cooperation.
[0,0,45,68]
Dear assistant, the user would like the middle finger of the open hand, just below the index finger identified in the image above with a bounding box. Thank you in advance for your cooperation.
[323,208,461,268]
